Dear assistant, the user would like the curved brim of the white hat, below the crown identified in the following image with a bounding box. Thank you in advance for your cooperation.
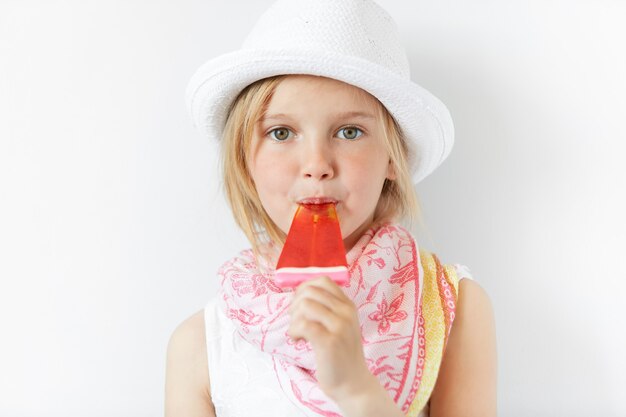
[186,49,454,183]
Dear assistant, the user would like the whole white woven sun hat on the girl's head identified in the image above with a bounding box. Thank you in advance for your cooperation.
[186,0,454,183]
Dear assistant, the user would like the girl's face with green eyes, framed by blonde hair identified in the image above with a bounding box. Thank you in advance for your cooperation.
[248,75,395,250]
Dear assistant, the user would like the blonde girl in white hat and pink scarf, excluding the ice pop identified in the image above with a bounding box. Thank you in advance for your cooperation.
[165,0,496,417]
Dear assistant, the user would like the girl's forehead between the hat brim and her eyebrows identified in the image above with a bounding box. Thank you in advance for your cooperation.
[268,75,378,111]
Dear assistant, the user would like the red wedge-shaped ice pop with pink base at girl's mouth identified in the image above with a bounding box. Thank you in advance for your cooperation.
[275,203,349,287]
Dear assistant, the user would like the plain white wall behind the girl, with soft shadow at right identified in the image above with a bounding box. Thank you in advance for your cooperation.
[0,0,626,417]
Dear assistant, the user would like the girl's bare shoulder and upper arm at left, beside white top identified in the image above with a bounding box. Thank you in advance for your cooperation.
[165,310,215,416]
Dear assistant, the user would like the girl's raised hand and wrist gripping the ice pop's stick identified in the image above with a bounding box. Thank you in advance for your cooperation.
[287,277,380,401]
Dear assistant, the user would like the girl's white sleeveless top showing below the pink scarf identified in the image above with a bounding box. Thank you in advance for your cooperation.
[204,297,428,417]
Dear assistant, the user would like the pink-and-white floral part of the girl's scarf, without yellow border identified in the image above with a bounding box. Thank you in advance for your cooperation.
[219,224,425,417]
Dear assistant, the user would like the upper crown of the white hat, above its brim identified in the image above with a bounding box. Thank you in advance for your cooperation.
[242,0,410,79]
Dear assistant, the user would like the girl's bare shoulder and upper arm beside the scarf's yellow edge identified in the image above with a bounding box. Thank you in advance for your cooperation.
[431,279,497,417]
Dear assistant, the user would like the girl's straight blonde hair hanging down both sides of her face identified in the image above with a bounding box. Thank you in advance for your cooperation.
[221,75,420,253]
